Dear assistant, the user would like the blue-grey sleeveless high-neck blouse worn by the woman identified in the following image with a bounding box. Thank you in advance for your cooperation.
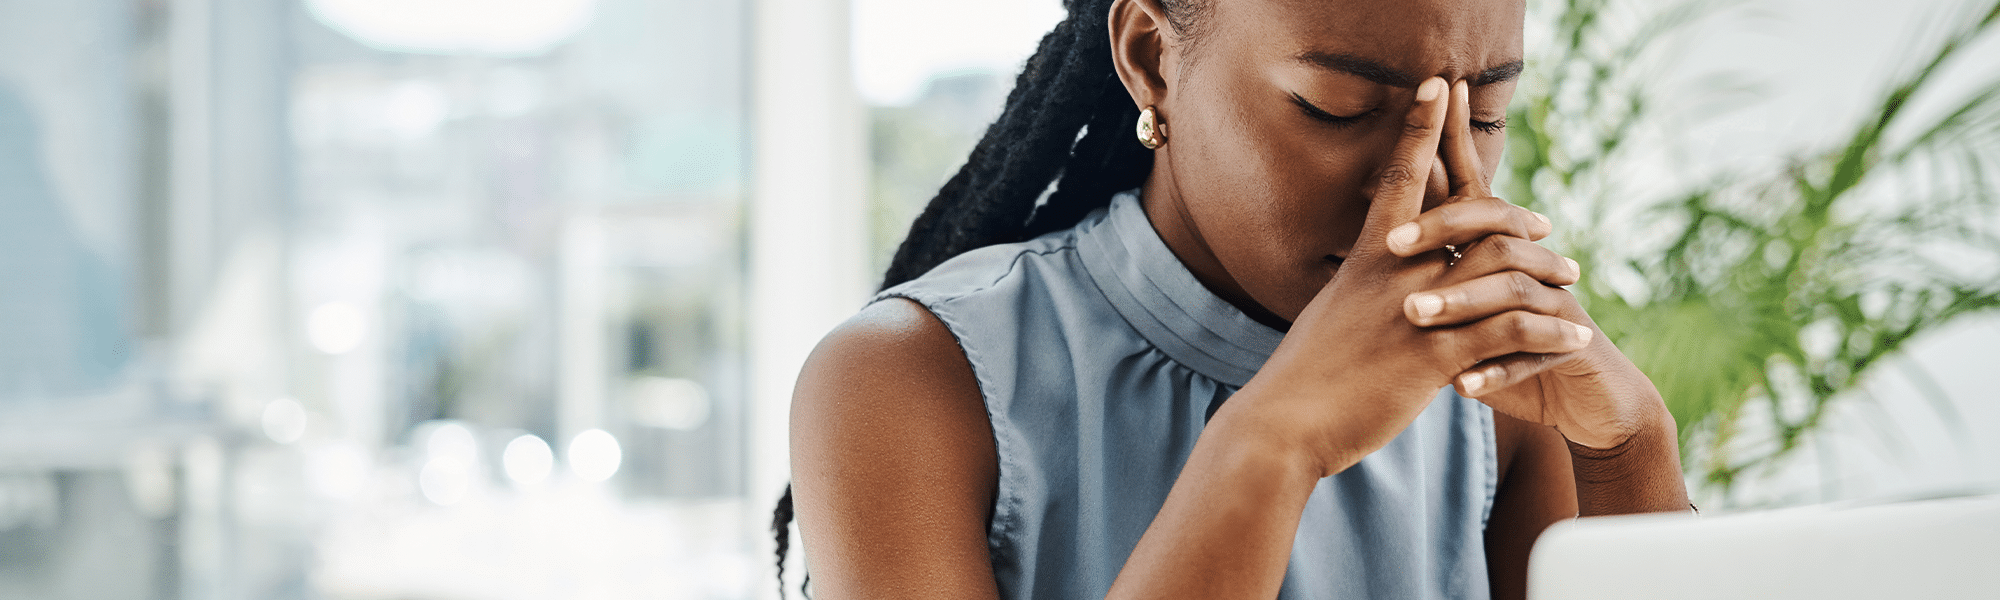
[876,192,1496,600]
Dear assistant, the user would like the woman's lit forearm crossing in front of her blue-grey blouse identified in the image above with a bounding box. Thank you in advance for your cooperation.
[1110,408,1318,598]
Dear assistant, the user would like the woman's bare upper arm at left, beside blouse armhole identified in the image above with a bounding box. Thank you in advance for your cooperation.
[792,300,998,600]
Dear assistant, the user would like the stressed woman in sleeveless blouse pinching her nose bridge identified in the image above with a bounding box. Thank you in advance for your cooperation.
[780,0,1688,598]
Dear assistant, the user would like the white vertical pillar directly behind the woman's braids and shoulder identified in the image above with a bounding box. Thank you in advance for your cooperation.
[748,0,874,596]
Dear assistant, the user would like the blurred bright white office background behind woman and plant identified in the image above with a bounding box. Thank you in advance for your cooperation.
[0,0,2000,600]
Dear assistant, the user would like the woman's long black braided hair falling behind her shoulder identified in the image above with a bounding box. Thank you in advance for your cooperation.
[770,0,1212,598]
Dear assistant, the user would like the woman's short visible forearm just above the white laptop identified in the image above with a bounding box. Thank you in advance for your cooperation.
[1570,406,1688,516]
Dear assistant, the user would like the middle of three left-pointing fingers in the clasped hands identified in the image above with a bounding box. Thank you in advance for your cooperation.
[1402,270,1576,328]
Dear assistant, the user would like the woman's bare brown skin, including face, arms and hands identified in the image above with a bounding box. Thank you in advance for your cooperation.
[792,0,1686,598]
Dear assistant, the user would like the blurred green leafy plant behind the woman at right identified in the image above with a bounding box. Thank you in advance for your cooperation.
[1506,0,2000,498]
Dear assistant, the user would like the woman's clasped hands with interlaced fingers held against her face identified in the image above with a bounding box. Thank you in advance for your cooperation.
[1218,78,1660,474]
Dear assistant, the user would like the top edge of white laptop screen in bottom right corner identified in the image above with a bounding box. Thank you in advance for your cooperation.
[1528,496,2000,600]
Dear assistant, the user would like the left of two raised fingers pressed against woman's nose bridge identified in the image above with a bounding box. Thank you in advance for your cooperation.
[1362,78,1446,253]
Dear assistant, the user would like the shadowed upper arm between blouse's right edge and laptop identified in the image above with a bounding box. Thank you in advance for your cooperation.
[1486,410,1576,600]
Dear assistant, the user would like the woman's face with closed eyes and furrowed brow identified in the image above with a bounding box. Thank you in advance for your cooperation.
[1146,0,1524,326]
